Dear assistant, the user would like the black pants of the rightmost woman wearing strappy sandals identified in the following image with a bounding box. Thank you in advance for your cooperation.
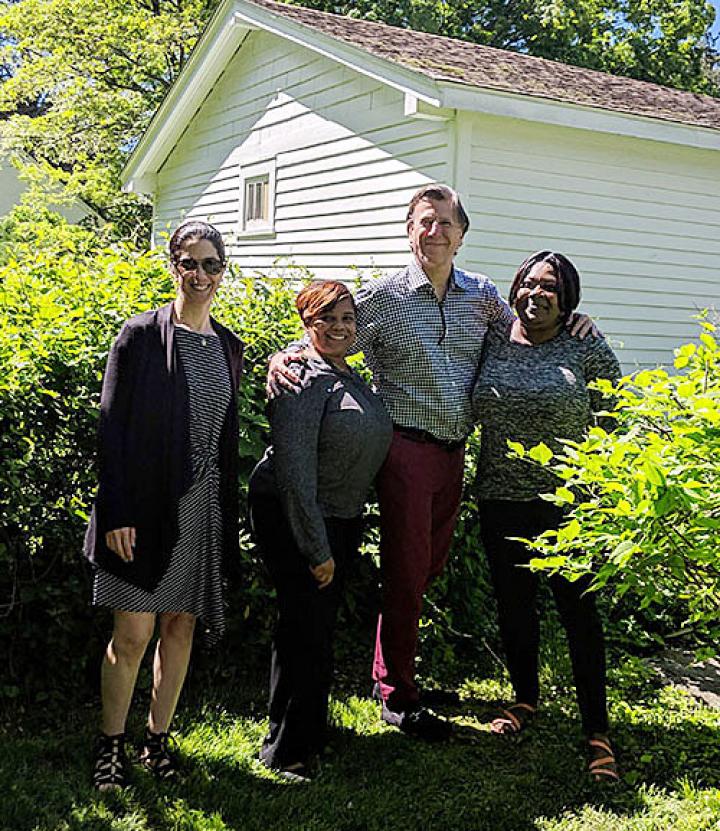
[480,499,608,734]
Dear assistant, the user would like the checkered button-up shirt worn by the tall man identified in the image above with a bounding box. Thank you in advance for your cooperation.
[356,259,513,441]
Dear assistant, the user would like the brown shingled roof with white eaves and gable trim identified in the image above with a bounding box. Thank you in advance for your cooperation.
[122,0,720,192]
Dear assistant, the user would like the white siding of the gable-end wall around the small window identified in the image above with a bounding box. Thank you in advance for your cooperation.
[155,32,450,270]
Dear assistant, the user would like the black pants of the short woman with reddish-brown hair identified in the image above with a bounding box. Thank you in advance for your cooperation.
[250,496,362,768]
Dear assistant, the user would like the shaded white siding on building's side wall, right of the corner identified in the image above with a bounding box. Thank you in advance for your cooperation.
[461,116,720,369]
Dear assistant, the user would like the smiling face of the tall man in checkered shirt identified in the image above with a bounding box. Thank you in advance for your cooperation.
[407,199,463,274]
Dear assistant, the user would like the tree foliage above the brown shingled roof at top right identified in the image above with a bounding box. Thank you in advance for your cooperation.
[292,0,720,95]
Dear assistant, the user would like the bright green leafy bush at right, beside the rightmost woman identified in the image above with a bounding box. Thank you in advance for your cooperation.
[513,321,720,644]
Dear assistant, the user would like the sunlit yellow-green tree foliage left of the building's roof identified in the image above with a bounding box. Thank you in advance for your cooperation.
[0,0,216,230]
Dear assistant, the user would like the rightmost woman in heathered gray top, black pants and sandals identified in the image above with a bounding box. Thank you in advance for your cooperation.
[473,251,620,780]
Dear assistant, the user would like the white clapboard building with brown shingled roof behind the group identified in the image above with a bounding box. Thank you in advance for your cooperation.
[124,0,720,369]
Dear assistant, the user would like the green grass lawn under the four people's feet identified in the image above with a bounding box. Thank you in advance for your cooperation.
[0,648,720,831]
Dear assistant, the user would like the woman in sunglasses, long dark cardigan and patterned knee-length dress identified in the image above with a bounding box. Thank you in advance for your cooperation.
[85,221,243,790]
